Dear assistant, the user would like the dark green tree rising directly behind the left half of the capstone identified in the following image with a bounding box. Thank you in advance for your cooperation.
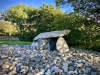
[29,4,63,34]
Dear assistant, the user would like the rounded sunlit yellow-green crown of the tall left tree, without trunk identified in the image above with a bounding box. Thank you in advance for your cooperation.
[5,3,32,24]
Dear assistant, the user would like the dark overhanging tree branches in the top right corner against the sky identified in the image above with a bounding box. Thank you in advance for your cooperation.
[56,0,100,21]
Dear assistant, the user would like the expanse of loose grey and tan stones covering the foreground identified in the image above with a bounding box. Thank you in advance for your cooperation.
[0,45,100,75]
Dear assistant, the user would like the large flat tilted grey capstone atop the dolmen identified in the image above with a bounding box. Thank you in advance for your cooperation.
[33,30,70,40]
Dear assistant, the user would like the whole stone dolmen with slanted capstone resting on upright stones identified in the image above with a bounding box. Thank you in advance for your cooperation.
[31,30,70,53]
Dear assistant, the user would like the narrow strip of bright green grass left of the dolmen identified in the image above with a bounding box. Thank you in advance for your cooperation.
[0,41,32,45]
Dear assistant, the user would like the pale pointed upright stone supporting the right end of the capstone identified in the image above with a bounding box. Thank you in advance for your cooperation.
[56,37,69,53]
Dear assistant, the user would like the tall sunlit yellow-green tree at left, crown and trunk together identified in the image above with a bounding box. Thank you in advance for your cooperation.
[5,3,34,37]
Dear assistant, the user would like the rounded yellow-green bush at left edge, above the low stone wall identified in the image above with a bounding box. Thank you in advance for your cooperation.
[0,21,17,35]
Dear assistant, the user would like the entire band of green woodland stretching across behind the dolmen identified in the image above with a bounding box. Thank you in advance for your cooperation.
[0,0,100,51]
